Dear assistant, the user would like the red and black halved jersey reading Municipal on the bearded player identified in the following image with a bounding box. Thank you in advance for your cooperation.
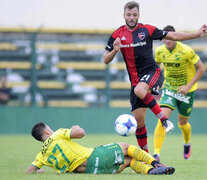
[105,23,167,86]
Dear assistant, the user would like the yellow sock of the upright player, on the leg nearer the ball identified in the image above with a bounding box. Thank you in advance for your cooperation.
[154,119,166,154]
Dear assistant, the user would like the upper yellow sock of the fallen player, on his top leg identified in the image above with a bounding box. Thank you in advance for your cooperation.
[128,145,155,165]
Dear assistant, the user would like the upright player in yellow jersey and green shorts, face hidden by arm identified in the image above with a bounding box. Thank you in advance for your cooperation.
[153,25,205,161]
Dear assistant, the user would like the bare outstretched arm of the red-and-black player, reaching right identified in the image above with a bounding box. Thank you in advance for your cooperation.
[164,25,207,41]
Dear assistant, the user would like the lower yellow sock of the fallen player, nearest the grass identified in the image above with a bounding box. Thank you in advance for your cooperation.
[130,158,152,174]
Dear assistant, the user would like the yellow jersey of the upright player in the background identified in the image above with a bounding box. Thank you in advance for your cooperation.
[155,42,200,92]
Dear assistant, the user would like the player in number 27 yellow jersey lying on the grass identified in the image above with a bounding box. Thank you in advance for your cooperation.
[27,122,175,175]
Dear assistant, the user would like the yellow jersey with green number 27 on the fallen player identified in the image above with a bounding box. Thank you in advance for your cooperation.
[32,129,94,173]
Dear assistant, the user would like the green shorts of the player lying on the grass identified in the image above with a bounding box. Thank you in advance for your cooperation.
[86,143,124,174]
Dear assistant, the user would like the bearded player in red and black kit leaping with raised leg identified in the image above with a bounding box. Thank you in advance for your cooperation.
[104,1,207,152]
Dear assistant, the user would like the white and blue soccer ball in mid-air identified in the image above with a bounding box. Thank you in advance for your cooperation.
[114,114,137,136]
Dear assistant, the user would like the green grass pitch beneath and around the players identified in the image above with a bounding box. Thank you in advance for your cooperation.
[0,134,207,180]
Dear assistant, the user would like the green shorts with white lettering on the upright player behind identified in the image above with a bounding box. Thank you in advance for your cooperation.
[160,88,195,117]
